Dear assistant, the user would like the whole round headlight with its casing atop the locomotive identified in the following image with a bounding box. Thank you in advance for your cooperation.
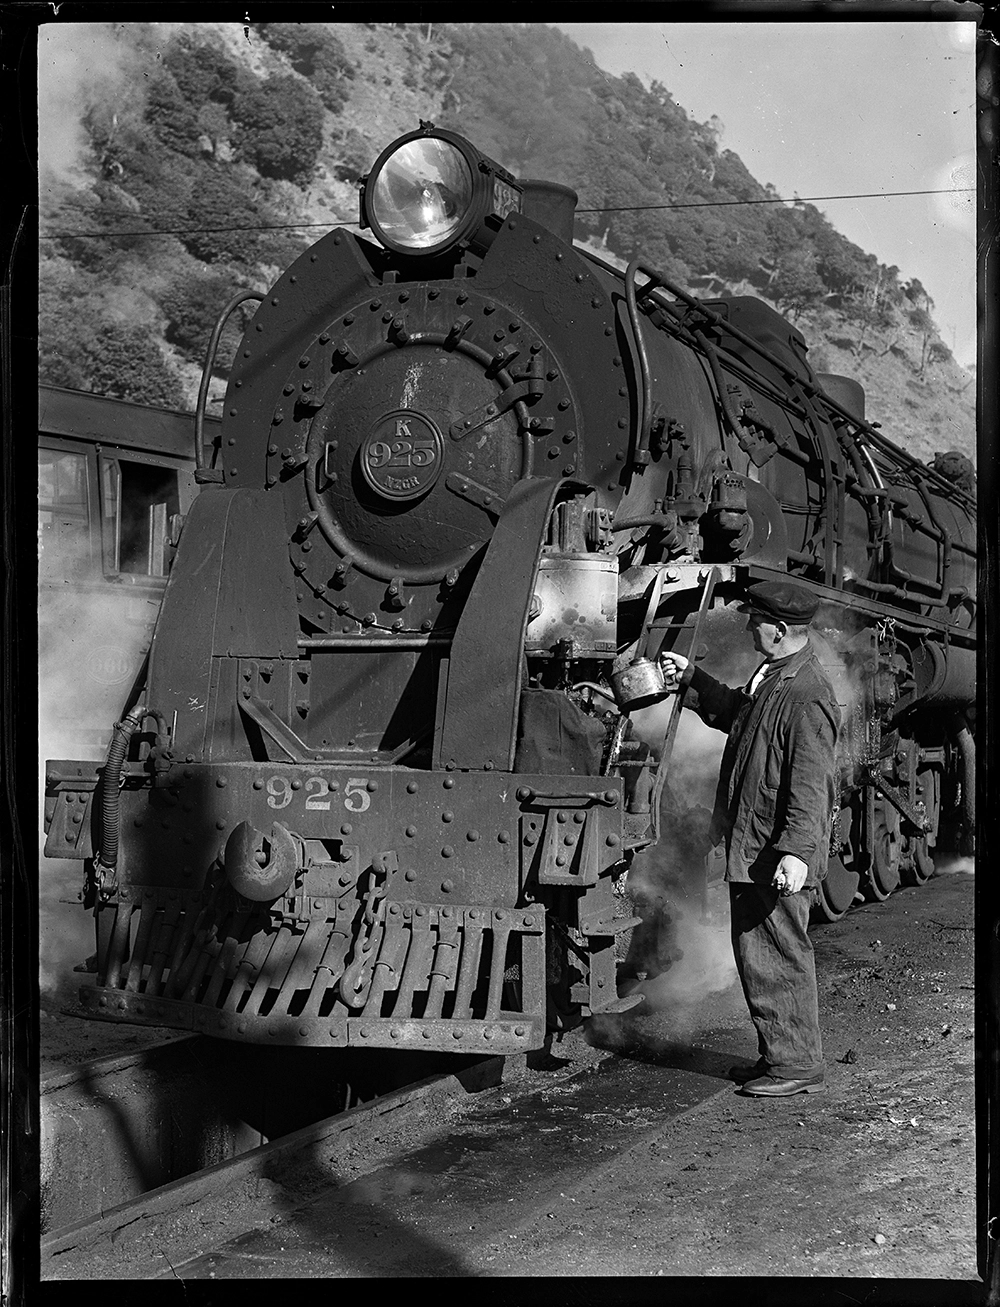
[361,125,522,255]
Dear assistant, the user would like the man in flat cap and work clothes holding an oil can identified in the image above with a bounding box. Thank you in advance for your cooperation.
[660,582,841,1098]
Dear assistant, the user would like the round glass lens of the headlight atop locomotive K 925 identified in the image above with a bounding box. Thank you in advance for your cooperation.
[370,136,473,250]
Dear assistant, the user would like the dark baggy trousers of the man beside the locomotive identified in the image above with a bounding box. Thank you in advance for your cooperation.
[729,882,825,1078]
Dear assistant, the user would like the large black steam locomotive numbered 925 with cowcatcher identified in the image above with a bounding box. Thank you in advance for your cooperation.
[47,124,975,1052]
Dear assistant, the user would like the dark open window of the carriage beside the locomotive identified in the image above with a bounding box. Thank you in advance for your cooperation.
[101,459,180,576]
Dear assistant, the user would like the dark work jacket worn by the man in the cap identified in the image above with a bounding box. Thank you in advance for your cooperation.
[681,644,841,886]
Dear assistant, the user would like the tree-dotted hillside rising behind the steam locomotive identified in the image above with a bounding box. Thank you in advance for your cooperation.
[39,24,975,459]
